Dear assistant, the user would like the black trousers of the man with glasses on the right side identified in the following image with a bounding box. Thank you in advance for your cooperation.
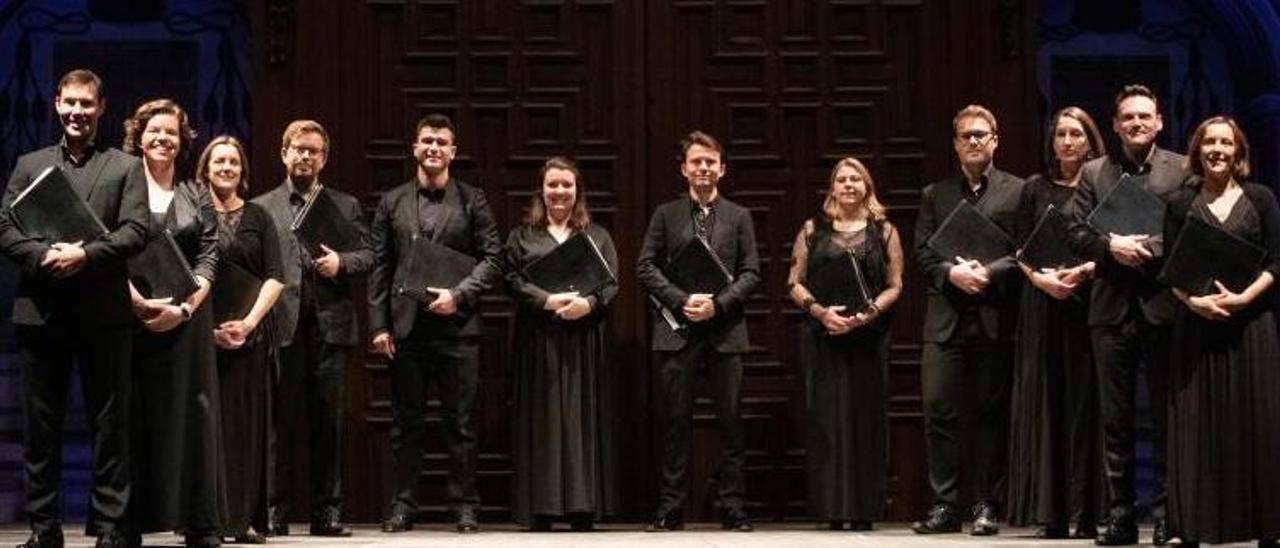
[920,315,1014,507]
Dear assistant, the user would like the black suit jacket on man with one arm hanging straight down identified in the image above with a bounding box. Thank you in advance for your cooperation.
[369,178,502,339]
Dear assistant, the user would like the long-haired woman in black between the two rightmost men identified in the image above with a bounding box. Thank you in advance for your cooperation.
[1007,106,1106,539]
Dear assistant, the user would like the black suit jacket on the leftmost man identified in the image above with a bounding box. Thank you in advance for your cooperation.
[0,145,147,325]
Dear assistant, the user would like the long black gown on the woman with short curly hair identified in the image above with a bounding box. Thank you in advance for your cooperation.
[129,181,227,534]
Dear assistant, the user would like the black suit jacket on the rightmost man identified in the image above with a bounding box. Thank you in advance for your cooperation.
[1065,149,1189,325]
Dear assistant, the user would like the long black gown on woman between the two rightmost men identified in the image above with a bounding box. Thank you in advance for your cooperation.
[1007,175,1106,529]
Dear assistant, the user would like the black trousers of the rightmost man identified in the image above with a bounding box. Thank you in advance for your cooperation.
[1091,314,1171,520]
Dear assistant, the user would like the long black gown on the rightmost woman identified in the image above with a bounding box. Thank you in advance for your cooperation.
[1165,183,1280,544]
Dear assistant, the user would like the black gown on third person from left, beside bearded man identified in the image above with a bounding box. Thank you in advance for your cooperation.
[210,202,284,536]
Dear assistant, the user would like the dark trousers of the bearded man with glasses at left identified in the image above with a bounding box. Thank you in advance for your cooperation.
[268,306,351,517]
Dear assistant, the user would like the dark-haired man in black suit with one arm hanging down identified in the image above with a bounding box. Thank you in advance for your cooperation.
[369,114,502,533]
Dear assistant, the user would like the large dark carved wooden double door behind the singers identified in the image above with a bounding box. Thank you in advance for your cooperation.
[251,0,1041,522]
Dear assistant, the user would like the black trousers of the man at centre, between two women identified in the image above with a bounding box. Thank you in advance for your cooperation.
[657,339,746,513]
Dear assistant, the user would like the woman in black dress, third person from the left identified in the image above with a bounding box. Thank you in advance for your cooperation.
[196,136,284,544]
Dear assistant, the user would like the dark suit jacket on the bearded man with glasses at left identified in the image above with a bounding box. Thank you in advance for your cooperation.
[253,181,374,346]
